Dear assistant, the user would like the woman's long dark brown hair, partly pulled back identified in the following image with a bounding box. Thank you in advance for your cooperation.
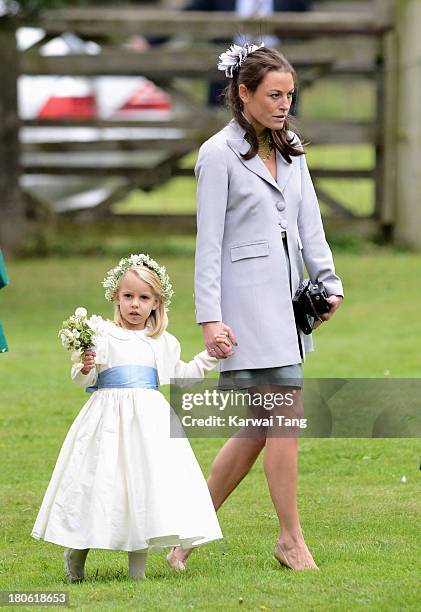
[225,47,304,163]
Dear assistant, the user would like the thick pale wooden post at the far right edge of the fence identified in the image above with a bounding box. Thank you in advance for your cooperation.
[394,0,421,249]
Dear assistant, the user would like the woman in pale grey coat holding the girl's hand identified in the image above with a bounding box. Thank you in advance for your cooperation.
[169,45,343,570]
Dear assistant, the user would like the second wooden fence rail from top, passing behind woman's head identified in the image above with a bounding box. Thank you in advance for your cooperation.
[21,40,381,79]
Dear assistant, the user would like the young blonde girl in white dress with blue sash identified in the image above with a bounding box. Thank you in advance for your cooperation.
[32,254,229,582]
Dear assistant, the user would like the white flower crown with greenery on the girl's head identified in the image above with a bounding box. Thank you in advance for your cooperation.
[102,253,174,308]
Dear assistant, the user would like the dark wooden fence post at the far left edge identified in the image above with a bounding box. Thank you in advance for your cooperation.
[0,17,25,255]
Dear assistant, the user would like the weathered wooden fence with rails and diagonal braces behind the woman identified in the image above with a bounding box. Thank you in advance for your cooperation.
[0,0,420,250]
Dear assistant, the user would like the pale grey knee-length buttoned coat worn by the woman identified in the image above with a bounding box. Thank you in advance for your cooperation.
[195,120,343,371]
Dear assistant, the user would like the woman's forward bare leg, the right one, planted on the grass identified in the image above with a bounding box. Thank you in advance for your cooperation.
[263,387,317,570]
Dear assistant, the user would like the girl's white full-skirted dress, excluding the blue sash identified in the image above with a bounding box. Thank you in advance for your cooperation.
[32,323,222,551]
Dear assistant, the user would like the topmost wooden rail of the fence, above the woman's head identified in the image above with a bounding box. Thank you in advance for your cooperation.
[36,8,393,41]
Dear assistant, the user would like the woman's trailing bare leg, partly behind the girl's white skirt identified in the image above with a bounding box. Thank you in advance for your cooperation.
[167,437,265,571]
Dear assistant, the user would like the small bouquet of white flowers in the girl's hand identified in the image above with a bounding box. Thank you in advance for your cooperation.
[58,308,102,359]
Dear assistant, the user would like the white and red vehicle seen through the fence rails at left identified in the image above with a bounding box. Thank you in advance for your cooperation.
[17,27,182,211]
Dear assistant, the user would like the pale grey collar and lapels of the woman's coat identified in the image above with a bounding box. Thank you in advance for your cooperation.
[227,119,292,192]
